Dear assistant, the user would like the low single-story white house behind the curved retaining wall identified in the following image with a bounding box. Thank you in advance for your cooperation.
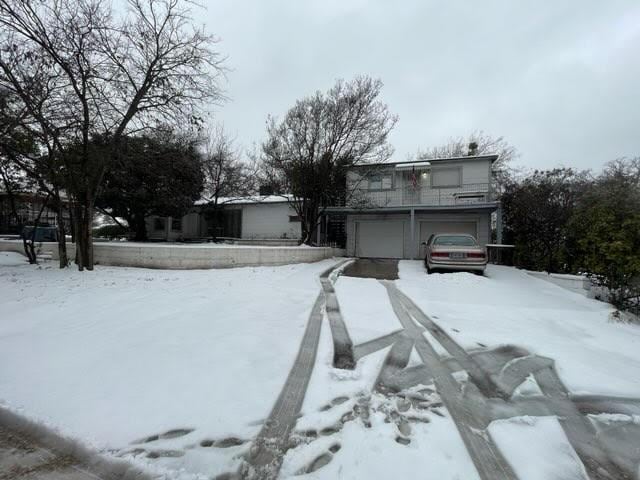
[147,195,301,243]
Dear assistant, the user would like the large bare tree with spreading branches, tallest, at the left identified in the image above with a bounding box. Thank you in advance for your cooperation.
[0,0,222,270]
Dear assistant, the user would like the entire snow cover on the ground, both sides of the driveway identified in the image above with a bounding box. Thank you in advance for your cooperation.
[0,253,640,480]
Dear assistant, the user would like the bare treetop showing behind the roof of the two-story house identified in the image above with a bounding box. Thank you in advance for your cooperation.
[416,130,519,191]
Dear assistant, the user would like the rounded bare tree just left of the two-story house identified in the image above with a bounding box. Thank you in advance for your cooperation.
[262,76,397,244]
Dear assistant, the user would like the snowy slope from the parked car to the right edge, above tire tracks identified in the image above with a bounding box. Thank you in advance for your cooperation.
[397,261,640,397]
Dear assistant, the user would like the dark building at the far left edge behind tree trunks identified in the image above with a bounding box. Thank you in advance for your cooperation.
[0,190,71,234]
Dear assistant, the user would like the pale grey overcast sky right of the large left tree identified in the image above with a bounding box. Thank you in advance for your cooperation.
[197,0,640,170]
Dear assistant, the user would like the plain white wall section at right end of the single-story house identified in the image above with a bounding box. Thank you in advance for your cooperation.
[242,203,301,239]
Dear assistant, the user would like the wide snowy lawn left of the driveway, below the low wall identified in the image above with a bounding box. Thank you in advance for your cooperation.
[0,253,334,478]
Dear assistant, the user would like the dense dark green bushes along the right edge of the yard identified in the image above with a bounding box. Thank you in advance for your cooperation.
[502,158,640,314]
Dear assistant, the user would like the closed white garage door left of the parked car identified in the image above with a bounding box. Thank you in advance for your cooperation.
[356,220,404,258]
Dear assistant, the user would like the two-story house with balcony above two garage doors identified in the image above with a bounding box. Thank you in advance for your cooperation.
[328,155,499,258]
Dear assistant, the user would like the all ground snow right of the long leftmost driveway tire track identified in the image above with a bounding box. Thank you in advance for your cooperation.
[281,261,640,480]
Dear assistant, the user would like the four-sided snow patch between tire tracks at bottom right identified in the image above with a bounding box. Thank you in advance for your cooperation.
[489,417,589,480]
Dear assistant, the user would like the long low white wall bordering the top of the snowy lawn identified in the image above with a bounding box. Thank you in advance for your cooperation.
[0,240,344,269]
